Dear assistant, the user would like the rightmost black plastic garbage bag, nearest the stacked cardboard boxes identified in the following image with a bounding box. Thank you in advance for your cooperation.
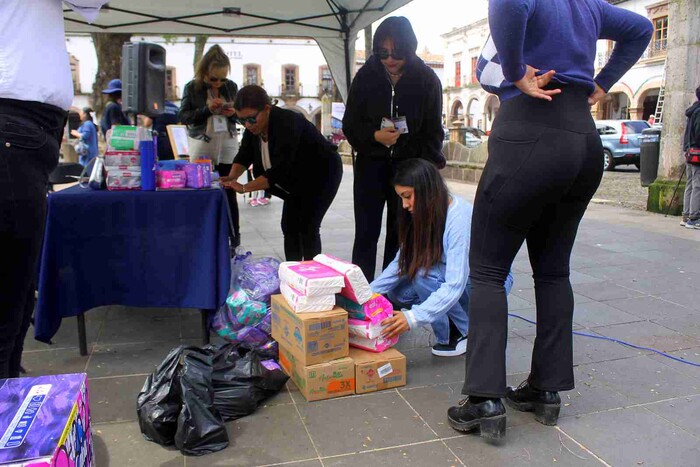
[212,344,289,421]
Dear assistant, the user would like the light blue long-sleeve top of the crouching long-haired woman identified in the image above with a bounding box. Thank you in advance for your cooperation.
[370,196,472,328]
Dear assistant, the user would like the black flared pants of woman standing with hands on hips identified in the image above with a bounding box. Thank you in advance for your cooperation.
[462,86,603,398]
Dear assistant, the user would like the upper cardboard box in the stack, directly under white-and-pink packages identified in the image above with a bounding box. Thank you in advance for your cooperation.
[272,295,348,366]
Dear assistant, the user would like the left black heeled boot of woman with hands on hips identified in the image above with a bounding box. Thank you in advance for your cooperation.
[447,398,506,440]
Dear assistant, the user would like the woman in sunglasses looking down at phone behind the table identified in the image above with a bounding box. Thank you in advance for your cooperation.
[179,45,240,249]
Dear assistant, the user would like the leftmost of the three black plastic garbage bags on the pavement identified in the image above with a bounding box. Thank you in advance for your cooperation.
[136,346,185,446]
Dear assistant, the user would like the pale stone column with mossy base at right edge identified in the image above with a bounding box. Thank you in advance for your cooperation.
[647,0,700,215]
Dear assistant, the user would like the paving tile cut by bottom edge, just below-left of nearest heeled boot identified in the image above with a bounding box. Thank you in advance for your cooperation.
[323,441,459,467]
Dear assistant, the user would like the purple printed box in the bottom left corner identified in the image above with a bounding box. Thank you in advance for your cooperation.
[0,373,95,467]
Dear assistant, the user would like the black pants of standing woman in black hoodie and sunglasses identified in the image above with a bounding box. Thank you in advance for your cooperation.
[352,156,401,282]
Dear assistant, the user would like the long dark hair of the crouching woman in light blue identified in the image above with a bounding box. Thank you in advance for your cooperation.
[393,158,450,280]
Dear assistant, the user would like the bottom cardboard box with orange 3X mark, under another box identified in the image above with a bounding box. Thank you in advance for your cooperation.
[279,345,355,402]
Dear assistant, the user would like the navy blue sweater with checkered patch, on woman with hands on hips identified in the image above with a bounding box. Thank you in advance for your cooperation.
[477,0,654,101]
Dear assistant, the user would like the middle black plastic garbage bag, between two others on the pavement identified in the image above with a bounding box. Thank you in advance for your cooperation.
[175,348,228,456]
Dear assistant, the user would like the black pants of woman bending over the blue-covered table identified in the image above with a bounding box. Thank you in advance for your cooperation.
[282,154,343,261]
